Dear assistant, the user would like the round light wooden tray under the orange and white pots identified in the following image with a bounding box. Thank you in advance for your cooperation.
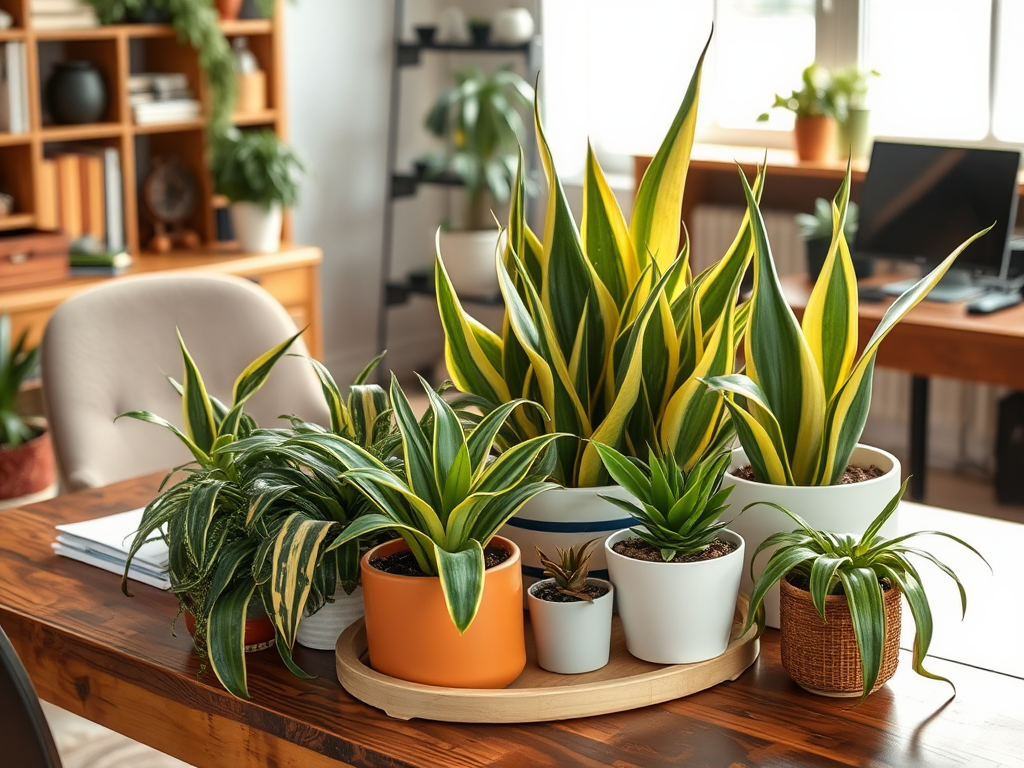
[335,595,760,723]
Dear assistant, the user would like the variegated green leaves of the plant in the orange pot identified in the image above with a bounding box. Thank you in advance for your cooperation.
[321,376,559,632]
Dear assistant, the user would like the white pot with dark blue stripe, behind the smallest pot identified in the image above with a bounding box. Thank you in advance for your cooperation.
[501,485,636,587]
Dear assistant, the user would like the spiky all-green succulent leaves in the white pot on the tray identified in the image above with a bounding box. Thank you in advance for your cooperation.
[595,443,732,562]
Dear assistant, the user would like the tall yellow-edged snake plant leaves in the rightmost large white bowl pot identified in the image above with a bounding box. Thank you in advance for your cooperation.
[705,167,988,485]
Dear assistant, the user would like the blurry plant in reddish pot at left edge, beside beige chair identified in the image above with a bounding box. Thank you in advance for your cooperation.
[0,312,56,507]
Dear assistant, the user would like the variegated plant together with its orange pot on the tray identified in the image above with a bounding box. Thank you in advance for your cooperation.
[315,377,559,688]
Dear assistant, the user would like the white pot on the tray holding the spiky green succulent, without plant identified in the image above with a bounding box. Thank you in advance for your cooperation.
[604,529,744,664]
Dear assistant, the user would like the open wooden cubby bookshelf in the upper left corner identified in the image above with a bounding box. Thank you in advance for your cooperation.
[0,0,291,254]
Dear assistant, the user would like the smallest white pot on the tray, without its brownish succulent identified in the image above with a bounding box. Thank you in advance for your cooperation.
[526,579,614,675]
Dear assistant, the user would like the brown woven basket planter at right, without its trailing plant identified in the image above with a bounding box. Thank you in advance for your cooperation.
[779,579,901,696]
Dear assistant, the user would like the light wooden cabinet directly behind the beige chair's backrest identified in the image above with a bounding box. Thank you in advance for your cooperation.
[0,245,324,357]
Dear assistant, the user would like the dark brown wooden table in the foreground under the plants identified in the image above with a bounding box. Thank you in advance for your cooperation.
[0,476,1024,768]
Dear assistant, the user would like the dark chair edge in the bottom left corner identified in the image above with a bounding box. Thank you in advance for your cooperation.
[0,628,60,768]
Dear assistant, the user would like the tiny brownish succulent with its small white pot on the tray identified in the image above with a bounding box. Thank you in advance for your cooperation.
[526,539,615,675]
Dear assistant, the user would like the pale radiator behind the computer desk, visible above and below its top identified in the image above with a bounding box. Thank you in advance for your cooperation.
[686,205,1009,474]
